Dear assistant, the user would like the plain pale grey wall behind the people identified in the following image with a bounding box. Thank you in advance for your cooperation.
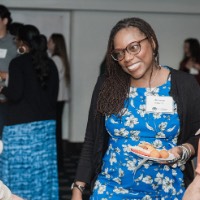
[1,0,200,142]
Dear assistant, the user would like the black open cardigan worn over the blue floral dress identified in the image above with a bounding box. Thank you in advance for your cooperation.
[75,68,200,190]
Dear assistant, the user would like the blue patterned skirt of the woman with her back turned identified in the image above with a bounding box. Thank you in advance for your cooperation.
[0,120,58,200]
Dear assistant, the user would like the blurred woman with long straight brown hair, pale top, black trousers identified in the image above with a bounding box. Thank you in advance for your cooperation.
[48,33,70,171]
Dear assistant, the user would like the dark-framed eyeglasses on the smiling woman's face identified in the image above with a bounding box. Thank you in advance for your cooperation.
[111,37,147,61]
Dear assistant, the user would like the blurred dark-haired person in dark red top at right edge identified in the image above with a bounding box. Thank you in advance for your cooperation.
[179,38,200,84]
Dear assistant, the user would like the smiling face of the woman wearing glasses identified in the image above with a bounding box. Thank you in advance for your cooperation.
[114,27,154,79]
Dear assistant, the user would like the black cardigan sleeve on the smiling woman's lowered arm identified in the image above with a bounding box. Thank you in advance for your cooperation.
[75,77,103,184]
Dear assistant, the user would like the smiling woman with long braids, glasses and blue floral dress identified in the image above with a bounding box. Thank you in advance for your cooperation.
[72,18,200,200]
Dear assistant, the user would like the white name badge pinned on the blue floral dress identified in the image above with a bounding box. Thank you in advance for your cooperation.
[146,96,174,113]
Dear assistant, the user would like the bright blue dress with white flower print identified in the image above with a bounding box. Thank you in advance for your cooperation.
[90,77,185,200]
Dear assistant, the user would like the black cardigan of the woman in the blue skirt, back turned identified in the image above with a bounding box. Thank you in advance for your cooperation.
[2,53,59,125]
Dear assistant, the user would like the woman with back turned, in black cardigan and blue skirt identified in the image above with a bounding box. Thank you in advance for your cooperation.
[0,25,59,200]
